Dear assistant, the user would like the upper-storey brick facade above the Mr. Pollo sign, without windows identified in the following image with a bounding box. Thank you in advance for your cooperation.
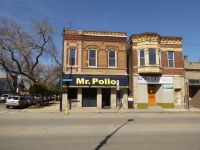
[64,30,127,75]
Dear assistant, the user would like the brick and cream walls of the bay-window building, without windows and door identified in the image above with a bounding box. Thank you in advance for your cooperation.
[127,32,185,107]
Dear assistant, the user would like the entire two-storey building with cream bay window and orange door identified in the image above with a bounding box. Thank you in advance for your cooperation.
[127,32,185,108]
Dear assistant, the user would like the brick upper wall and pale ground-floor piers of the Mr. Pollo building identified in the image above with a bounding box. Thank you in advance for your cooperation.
[62,30,128,108]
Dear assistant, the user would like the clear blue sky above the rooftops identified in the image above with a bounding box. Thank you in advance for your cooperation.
[0,0,200,62]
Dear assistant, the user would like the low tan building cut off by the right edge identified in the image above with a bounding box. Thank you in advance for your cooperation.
[184,56,200,105]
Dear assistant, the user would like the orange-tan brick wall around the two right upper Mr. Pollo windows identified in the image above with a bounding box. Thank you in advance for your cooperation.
[81,41,127,74]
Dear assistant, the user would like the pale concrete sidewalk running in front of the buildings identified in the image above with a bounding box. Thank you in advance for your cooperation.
[20,101,200,114]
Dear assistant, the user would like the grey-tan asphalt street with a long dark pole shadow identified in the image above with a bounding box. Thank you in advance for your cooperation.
[0,109,200,150]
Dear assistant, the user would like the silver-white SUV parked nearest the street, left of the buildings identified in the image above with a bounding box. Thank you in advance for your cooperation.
[5,95,28,108]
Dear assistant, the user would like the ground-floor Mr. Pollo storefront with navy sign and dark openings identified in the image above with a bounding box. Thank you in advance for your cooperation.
[63,75,128,108]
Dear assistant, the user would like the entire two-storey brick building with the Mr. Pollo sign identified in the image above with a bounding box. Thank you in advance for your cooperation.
[62,29,128,109]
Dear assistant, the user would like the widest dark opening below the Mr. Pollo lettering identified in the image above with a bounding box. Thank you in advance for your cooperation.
[82,88,97,107]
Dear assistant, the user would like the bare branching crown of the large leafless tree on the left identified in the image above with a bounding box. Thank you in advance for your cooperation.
[0,17,58,83]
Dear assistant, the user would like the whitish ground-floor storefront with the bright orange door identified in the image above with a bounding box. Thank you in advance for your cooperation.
[137,76,174,108]
